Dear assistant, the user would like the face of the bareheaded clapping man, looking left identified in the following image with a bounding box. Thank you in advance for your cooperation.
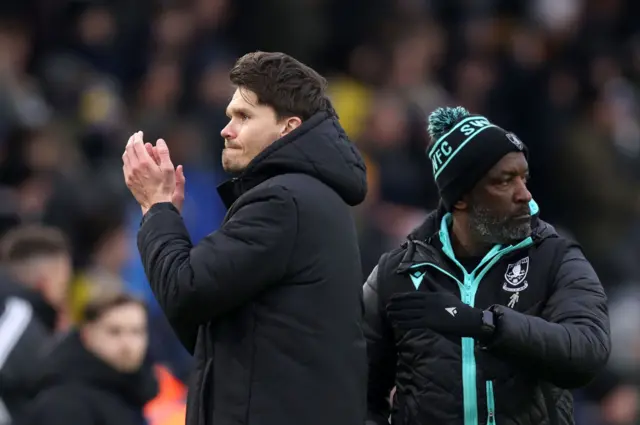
[220,88,287,173]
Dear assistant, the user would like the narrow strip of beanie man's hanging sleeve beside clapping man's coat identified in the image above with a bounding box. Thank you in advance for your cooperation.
[363,266,396,425]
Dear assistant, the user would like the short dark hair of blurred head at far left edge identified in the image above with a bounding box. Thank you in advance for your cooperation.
[0,224,71,263]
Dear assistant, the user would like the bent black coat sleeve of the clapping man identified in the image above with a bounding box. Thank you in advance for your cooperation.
[138,186,297,353]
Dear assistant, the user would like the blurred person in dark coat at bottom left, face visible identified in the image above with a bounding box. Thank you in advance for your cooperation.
[27,293,158,425]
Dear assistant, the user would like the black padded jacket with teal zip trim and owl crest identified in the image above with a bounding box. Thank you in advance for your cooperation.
[364,205,611,425]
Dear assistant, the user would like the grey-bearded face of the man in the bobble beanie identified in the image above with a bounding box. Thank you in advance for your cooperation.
[468,152,531,244]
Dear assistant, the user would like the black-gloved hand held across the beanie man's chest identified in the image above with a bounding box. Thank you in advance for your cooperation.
[387,291,482,338]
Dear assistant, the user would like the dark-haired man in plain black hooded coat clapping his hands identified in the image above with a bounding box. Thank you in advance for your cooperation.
[123,52,367,425]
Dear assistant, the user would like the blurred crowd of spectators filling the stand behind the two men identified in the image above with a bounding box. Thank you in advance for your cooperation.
[0,0,640,425]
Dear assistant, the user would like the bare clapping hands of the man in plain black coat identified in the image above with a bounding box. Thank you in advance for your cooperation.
[122,131,184,214]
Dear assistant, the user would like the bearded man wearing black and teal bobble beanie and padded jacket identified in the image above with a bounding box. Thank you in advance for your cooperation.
[364,107,610,425]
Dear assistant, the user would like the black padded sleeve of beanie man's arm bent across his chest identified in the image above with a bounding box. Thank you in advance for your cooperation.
[489,245,611,389]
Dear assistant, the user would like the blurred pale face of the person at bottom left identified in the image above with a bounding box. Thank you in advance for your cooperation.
[82,303,148,373]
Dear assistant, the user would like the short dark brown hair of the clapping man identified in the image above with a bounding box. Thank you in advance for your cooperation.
[229,52,336,121]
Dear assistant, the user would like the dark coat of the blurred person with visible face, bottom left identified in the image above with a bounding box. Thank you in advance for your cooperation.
[27,332,158,425]
